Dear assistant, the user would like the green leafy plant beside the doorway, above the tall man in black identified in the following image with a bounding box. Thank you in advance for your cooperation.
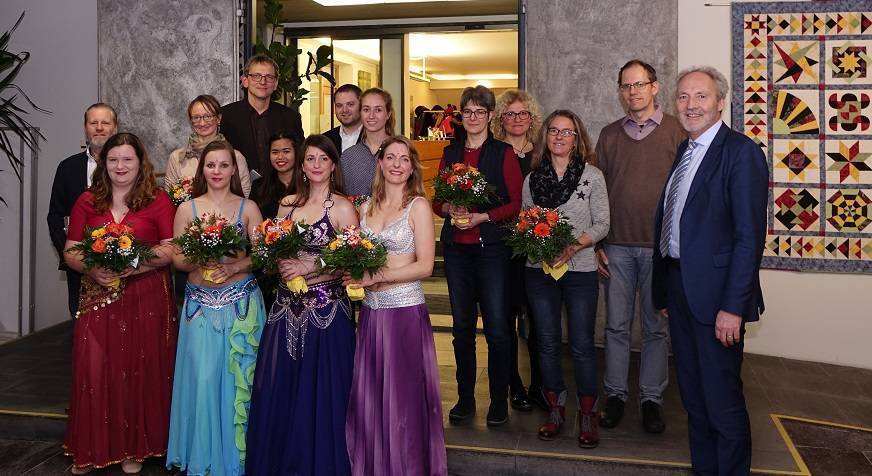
[254,0,336,109]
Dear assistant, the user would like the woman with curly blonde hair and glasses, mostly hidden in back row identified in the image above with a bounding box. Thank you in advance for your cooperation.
[490,89,548,412]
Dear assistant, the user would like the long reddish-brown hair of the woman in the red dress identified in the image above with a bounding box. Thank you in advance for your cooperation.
[90,132,158,213]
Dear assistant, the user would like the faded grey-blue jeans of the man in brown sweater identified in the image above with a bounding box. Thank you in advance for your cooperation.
[603,245,669,405]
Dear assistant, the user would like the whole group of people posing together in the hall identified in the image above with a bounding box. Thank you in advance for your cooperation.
[49,52,768,475]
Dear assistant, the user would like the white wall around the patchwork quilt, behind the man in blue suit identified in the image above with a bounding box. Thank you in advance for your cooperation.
[678,0,872,368]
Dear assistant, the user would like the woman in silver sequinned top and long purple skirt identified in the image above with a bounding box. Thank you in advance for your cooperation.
[345,136,448,476]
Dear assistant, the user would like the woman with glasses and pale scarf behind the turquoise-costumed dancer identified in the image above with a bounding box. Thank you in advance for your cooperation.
[164,94,251,197]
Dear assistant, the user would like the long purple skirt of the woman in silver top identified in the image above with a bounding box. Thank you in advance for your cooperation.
[345,304,448,476]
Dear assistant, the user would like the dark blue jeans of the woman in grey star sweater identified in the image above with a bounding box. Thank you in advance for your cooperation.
[526,268,599,396]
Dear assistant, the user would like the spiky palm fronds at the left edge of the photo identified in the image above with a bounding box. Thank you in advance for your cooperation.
[0,12,51,204]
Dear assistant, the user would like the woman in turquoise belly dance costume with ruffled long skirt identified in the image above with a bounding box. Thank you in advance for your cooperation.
[167,141,266,476]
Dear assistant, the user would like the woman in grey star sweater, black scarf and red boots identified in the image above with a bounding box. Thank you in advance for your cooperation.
[523,109,609,448]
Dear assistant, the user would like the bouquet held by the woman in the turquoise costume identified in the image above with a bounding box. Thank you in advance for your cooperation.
[173,213,248,284]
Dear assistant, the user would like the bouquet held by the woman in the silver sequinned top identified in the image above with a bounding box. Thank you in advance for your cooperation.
[321,225,388,301]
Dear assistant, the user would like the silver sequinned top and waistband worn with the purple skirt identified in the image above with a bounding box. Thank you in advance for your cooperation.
[360,197,426,309]
